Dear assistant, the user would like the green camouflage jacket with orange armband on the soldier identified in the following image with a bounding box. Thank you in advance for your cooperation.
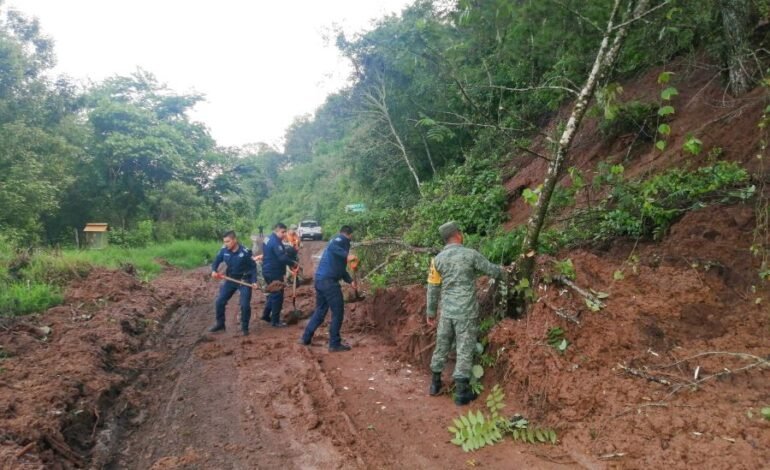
[428,243,503,319]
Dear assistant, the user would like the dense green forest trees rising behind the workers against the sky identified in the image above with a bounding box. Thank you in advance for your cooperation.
[0,0,768,248]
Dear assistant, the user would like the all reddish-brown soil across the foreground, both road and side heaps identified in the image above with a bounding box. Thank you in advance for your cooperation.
[0,206,770,469]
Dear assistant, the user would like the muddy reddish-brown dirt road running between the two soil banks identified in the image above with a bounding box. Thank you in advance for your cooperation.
[109,243,560,469]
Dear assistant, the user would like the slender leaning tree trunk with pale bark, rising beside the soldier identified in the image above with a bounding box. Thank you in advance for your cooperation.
[519,0,650,285]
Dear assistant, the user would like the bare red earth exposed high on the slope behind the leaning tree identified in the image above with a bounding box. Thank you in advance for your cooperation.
[505,61,767,228]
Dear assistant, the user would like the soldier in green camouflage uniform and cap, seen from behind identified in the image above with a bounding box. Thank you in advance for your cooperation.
[427,222,504,405]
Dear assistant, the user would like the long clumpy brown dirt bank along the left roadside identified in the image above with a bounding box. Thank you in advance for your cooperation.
[0,269,207,468]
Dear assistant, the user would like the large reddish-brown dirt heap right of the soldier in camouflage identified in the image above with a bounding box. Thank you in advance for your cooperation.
[489,207,770,468]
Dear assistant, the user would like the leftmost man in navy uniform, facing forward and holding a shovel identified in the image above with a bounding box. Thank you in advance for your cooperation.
[209,230,259,336]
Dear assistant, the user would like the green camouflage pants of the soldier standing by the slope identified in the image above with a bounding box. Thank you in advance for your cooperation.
[430,316,479,379]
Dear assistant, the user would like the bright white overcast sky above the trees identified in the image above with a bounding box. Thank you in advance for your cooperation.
[5,0,411,145]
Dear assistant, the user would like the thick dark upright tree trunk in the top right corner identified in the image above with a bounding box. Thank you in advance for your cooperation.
[719,0,756,96]
